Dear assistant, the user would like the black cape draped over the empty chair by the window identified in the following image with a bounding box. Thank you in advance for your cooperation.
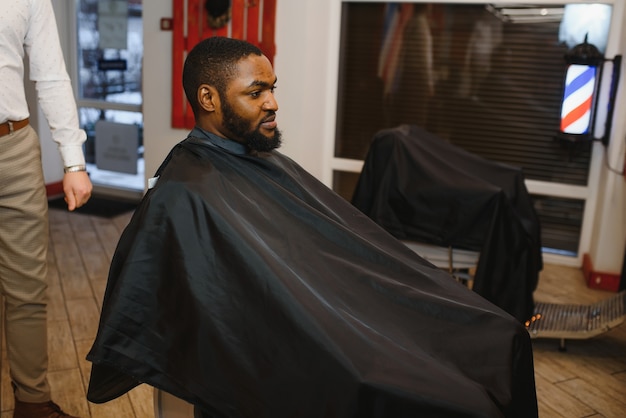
[352,125,543,322]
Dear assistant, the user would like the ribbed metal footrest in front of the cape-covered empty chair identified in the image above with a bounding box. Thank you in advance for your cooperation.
[526,291,626,339]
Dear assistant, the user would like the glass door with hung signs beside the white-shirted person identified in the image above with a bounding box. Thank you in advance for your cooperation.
[75,0,144,199]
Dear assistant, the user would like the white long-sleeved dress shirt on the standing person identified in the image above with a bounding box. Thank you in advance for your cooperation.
[0,0,86,167]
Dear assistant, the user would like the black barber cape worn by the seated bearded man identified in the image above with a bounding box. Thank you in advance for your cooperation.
[87,129,537,418]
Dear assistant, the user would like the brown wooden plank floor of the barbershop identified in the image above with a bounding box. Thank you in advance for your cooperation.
[0,210,626,418]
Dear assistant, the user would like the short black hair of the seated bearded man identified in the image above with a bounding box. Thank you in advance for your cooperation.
[183,36,263,116]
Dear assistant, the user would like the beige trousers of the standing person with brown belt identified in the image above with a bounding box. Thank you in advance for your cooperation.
[0,125,50,402]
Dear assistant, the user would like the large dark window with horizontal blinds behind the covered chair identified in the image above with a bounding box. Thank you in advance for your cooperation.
[333,2,611,256]
